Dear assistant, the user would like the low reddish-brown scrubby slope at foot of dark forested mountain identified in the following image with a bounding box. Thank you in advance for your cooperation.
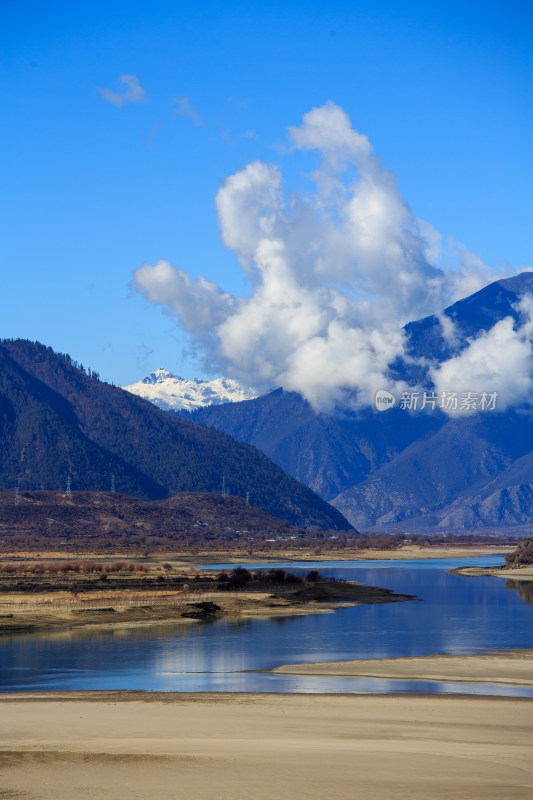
[0,490,308,550]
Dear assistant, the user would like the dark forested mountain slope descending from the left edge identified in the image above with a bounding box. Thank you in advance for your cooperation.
[0,339,350,530]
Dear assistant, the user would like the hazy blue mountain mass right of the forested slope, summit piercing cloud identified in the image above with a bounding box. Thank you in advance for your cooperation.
[193,272,533,530]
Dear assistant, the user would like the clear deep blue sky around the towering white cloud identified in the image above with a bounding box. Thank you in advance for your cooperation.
[0,0,533,384]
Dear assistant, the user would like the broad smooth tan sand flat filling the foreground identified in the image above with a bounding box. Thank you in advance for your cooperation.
[0,692,533,800]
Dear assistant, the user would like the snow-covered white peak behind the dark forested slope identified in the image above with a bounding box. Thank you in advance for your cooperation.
[123,368,257,412]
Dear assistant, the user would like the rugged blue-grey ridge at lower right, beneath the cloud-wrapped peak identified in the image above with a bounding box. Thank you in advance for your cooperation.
[333,411,533,529]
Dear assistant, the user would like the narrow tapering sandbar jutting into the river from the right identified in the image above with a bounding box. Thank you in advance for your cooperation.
[272,650,533,686]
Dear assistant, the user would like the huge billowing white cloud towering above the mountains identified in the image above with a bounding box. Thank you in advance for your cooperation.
[134,103,524,411]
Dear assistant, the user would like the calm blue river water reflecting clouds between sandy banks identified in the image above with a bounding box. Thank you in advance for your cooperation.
[0,556,533,697]
